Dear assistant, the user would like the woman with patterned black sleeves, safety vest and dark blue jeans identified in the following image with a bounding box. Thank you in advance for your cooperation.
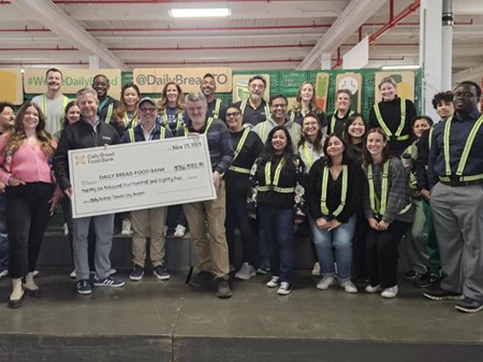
[248,126,305,295]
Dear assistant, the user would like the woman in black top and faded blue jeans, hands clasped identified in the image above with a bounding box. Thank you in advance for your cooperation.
[307,134,363,293]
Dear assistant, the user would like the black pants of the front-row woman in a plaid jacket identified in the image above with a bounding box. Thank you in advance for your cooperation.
[366,221,411,289]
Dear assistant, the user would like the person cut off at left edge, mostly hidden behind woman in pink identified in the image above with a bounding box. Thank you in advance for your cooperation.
[0,102,15,279]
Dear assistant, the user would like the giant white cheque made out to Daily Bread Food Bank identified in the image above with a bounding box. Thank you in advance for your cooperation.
[69,135,216,218]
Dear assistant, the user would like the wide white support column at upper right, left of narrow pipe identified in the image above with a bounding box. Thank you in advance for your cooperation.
[419,0,443,120]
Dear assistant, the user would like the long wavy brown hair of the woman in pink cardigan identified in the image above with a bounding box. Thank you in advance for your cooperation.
[5,102,55,157]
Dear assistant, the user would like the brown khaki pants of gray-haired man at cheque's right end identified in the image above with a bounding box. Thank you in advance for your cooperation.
[183,181,230,278]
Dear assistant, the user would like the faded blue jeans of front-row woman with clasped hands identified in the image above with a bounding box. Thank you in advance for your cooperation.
[309,215,357,284]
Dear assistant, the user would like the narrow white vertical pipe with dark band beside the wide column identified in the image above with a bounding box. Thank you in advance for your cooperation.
[441,0,454,91]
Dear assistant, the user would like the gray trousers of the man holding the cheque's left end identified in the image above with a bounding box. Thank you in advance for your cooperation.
[73,214,114,280]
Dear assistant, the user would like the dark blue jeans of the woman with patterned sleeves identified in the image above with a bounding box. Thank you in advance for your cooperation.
[258,204,294,283]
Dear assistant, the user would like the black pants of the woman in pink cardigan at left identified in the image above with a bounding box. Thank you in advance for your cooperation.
[6,182,55,278]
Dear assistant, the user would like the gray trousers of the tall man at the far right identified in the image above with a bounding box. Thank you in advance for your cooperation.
[431,183,483,302]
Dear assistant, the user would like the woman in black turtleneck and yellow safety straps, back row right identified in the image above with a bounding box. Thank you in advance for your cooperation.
[369,77,417,157]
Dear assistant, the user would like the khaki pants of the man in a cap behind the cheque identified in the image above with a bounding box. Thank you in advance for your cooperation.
[131,207,168,267]
